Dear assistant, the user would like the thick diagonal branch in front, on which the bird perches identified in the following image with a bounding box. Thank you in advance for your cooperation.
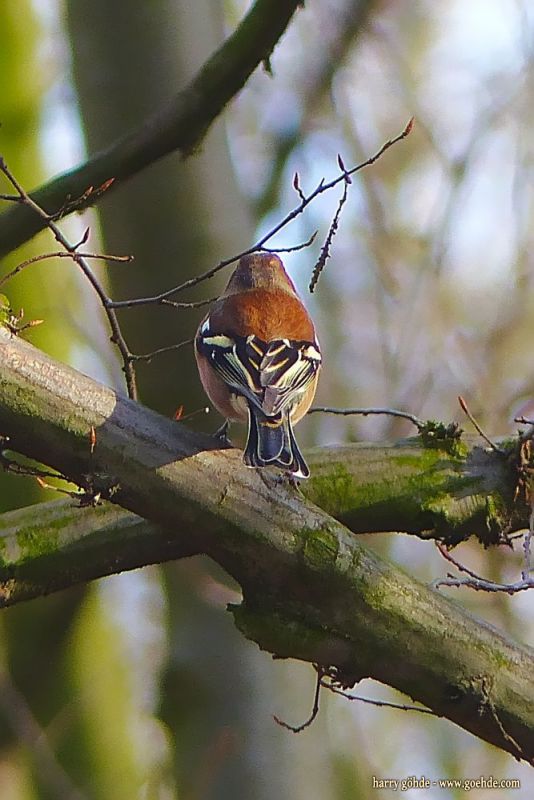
[0,330,534,761]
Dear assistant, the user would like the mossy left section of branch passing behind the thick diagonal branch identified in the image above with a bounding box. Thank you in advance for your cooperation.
[0,498,195,607]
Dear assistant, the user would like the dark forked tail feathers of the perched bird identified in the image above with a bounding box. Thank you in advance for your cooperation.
[243,406,310,478]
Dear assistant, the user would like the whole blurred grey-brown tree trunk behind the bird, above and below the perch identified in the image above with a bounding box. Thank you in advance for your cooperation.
[63,6,326,800]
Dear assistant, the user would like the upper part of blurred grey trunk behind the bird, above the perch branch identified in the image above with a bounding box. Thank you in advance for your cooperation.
[67,0,249,416]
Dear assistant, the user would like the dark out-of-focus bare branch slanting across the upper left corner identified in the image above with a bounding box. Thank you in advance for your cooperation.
[0,0,301,256]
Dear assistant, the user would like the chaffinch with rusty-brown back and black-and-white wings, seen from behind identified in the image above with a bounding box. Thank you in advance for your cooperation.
[195,253,321,478]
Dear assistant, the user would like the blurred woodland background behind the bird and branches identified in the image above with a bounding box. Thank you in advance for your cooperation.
[0,0,534,800]
